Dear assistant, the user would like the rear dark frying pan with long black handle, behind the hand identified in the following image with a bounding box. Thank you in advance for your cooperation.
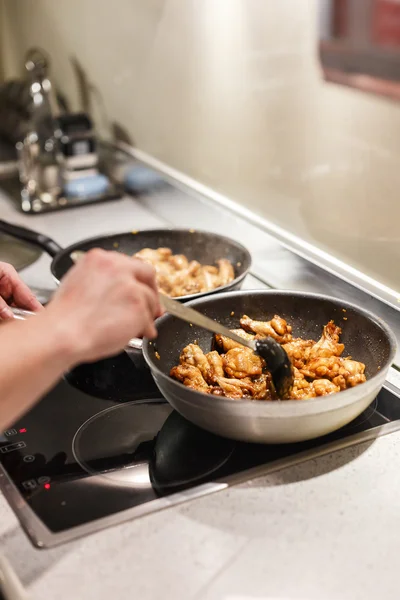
[0,220,251,301]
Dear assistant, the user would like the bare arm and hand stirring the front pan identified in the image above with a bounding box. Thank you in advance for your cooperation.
[0,250,161,431]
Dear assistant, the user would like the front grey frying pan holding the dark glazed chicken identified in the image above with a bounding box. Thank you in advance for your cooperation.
[143,290,396,444]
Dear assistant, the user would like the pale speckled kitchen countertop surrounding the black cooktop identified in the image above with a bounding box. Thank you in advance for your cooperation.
[0,185,400,600]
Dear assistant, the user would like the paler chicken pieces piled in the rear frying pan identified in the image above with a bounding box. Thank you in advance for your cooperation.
[134,248,235,298]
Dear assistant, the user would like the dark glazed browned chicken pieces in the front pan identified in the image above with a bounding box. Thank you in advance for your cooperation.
[170,315,366,400]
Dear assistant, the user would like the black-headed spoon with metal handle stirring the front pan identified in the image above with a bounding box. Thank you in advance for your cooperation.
[160,294,293,398]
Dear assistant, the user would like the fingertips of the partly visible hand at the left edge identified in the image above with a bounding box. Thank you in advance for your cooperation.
[0,262,43,320]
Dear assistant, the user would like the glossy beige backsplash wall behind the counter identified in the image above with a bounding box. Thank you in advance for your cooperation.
[0,0,400,295]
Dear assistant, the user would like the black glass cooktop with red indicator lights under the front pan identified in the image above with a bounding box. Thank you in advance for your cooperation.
[0,354,400,546]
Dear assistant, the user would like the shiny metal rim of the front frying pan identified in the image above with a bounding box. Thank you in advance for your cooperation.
[143,289,397,418]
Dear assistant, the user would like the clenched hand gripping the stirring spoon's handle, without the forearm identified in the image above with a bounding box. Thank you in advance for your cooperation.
[46,249,163,362]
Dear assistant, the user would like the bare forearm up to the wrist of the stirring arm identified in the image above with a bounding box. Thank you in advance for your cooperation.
[0,310,76,431]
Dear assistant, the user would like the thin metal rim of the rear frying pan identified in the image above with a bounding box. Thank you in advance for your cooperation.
[50,227,252,302]
